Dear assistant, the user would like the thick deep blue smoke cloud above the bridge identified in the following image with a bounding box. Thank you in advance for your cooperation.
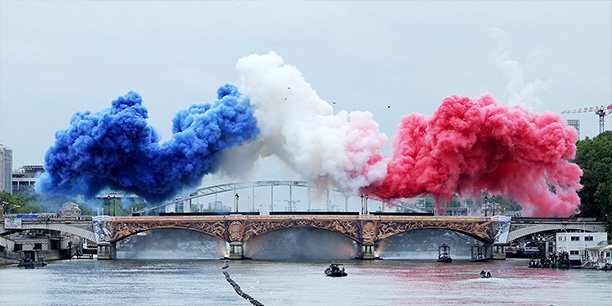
[36,84,259,202]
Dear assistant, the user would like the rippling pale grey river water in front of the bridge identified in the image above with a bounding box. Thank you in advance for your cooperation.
[0,259,612,305]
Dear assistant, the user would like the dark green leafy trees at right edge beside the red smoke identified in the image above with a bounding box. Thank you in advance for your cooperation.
[574,131,612,237]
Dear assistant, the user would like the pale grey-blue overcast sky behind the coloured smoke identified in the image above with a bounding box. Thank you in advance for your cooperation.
[0,1,612,201]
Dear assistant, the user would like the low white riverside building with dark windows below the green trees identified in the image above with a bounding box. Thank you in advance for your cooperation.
[555,232,608,261]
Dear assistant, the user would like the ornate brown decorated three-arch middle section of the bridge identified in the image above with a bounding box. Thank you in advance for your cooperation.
[93,215,510,259]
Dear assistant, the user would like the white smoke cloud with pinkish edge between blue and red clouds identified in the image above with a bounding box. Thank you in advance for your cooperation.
[222,52,387,194]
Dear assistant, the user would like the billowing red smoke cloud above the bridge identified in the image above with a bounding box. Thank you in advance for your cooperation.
[373,95,582,216]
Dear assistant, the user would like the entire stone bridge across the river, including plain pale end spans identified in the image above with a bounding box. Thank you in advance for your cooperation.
[0,214,606,259]
